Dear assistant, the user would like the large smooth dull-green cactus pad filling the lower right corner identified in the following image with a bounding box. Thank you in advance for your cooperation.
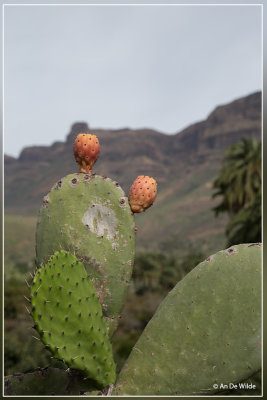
[115,244,261,395]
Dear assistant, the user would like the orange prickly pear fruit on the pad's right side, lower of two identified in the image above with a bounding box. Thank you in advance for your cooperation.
[129,175,157,213]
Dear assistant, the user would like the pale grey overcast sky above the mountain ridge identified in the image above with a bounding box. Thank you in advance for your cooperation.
[4,6,262,156]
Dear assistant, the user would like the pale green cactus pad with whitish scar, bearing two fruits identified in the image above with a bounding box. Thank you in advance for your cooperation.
[36,173,135,335]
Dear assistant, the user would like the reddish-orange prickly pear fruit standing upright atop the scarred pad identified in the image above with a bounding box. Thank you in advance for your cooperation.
[74,133,100,174]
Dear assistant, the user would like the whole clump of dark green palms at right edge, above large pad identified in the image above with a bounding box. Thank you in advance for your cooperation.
[213,138,261,246]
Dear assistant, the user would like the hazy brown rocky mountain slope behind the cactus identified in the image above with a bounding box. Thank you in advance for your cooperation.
[4,92,261,252]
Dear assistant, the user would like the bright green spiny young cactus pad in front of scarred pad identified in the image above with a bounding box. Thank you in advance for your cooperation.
[31,250,115,387]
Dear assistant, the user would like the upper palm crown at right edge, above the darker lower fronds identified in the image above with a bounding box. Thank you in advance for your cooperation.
[213,138,261,216]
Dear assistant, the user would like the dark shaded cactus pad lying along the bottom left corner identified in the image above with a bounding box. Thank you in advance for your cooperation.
[5,368,99,396]
